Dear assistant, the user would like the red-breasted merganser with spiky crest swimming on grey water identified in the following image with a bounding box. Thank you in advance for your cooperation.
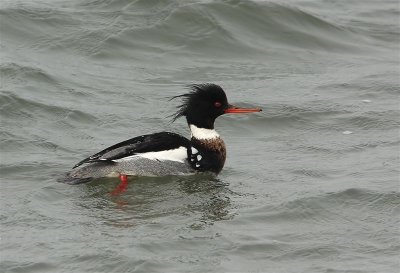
[60,83,261,188]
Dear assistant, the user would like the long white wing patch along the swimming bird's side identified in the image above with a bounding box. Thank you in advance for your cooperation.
[113,146,187,163]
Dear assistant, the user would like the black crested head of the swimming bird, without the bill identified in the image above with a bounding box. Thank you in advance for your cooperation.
[173,83,229,129]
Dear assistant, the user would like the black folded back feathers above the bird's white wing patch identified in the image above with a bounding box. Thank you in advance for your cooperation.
[73,132,190,169]
